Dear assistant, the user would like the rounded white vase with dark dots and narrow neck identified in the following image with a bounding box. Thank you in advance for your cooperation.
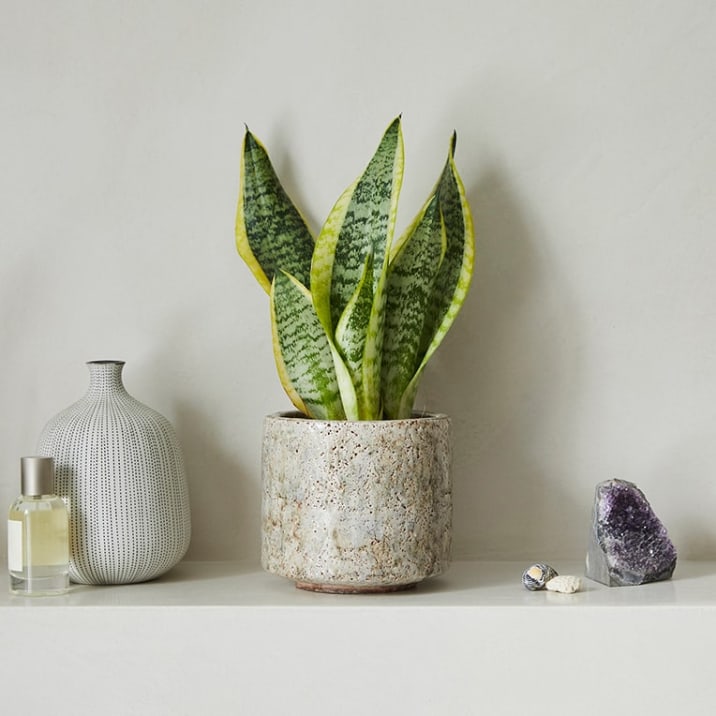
[38,361,191,584]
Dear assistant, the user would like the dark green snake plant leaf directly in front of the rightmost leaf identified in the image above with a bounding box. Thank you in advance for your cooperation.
[381,193,447,419]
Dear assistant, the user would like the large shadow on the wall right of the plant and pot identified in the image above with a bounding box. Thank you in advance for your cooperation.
[425,168,591,559]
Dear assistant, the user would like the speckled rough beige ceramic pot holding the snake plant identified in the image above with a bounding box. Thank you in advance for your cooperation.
[261,413,452,593]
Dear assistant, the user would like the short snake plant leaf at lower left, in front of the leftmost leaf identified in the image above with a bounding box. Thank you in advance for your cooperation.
[270,271,346,420]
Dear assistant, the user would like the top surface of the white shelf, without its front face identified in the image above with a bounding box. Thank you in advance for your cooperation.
[0,561,716,609]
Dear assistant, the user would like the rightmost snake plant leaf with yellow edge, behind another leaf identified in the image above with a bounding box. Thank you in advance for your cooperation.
[384,134,475,418]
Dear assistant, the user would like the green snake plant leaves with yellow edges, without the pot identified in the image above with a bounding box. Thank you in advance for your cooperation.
[236,117,474,420]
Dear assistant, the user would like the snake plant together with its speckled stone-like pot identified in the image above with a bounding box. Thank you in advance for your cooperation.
[236,117,474,592]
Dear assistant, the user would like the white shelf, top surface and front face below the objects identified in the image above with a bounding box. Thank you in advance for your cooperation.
[0,562,716,716]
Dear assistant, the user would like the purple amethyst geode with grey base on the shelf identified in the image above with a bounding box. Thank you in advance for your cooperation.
[586,480,676,587]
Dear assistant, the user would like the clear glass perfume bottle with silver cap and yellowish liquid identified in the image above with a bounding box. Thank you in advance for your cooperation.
[7,457,70,596]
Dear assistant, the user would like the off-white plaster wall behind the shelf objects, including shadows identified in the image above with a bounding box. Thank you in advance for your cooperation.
[0,0,716,560]
